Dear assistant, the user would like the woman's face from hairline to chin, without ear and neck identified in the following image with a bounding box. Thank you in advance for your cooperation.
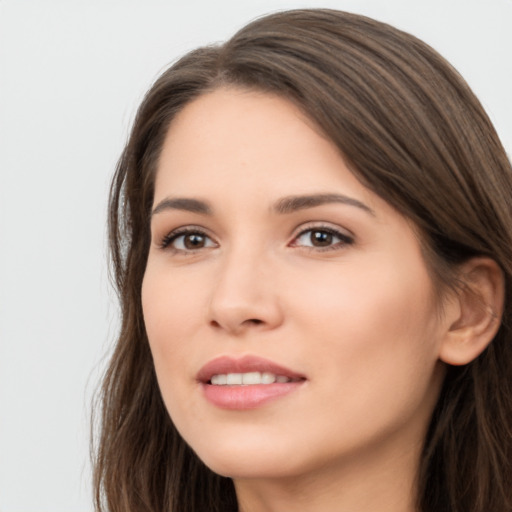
[142,89,446,478]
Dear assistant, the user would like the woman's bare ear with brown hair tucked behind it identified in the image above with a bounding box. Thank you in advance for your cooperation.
[439,257,505,366]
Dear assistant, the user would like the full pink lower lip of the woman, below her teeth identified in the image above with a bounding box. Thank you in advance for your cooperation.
[203,381,304,410]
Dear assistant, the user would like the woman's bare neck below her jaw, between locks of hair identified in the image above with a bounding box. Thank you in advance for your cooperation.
[235,436,421,512]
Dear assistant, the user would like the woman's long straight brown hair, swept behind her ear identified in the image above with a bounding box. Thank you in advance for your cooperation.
[94,9,512,512]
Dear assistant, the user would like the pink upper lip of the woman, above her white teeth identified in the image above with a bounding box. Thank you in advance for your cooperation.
[197,355,304,382]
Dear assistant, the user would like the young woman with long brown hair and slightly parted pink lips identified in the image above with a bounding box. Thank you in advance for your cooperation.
[95,10,512,512]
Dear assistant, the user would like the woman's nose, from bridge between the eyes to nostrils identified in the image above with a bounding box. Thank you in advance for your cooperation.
[209,245,283,336]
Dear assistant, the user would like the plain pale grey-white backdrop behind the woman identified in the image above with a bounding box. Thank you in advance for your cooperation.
[0,0,512,512]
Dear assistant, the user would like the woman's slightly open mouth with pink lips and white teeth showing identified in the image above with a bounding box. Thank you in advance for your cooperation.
[197,356,306,410]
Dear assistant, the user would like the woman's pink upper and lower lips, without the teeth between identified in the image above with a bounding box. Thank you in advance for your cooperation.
[197,356,305,410]
